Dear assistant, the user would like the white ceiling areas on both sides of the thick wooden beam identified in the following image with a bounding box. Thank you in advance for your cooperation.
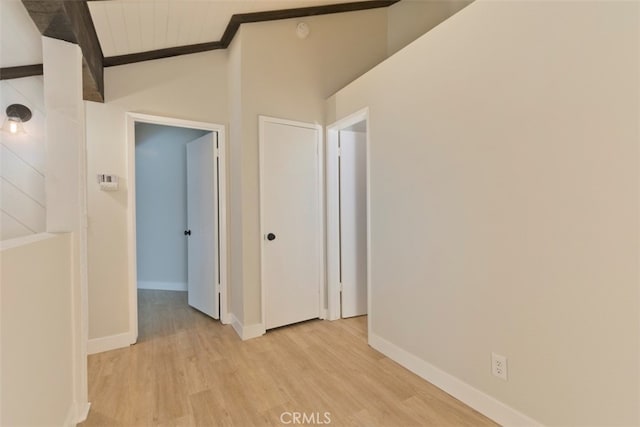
[0,0,372,67]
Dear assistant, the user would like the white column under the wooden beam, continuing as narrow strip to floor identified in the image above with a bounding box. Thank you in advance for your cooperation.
[42,37,89,423]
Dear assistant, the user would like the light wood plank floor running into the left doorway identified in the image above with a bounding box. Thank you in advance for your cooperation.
[81,291,495,427]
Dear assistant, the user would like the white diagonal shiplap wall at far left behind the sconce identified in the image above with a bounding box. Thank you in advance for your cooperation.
[0,77,46,240]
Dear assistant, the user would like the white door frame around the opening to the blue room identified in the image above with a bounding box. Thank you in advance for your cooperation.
[126,112,230,343]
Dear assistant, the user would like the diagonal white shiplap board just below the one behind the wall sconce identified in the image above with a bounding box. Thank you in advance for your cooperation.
[0,144,45,206]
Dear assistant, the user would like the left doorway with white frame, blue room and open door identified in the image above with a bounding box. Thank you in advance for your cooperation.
[127,113,228,342]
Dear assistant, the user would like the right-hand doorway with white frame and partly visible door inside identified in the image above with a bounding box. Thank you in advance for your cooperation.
[326,110,369,320]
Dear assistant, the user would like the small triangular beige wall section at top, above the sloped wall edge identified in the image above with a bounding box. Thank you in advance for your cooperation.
[387,0,473,56]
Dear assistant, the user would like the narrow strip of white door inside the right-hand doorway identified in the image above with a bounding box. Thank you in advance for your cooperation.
[339,131,367,317]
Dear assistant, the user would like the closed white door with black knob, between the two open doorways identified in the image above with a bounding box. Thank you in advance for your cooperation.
[260,117,322,329]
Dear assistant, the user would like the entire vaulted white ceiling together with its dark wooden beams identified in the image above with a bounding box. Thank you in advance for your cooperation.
[0,0,399,101]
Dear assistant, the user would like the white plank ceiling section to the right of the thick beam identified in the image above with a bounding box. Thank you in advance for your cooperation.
[89,0,370,57]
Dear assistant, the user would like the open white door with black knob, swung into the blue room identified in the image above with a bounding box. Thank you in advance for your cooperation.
[187,132,220,319]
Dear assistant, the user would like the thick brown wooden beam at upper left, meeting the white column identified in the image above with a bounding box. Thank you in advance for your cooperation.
[22,0,104,102]
